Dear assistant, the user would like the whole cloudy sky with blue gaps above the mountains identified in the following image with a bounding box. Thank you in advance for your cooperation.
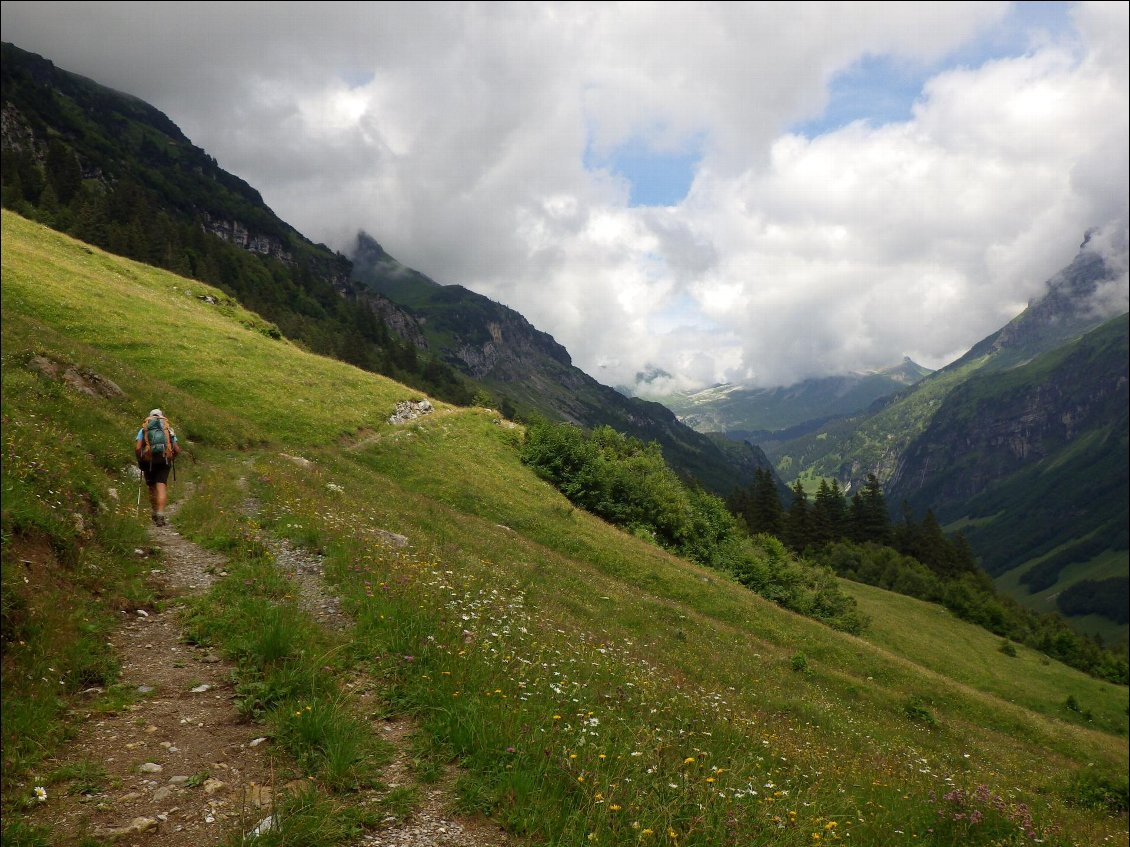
[2,0,1130,391]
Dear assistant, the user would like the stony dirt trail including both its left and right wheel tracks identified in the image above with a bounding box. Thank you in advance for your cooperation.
[29,490,514,847]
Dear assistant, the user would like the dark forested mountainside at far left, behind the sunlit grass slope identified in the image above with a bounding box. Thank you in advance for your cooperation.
[0,43,461,401]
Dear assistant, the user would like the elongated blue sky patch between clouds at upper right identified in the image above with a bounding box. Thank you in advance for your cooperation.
[791,0,1075,138]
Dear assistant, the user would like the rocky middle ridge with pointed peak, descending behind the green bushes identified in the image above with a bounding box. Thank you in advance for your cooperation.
[353,233,772,496]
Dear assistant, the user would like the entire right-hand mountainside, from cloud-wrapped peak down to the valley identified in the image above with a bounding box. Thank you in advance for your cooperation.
[762,238,1130,640]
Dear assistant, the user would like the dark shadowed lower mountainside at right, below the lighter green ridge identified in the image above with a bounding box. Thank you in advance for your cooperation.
[889,315,1130,627]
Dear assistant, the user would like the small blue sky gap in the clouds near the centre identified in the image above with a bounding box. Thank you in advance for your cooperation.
[584,138,702,207]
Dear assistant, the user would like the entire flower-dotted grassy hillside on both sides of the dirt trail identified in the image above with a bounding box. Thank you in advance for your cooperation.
[2,211,1128,847]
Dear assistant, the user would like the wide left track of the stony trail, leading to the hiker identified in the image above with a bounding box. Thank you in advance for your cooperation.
[29,507,275,847]
